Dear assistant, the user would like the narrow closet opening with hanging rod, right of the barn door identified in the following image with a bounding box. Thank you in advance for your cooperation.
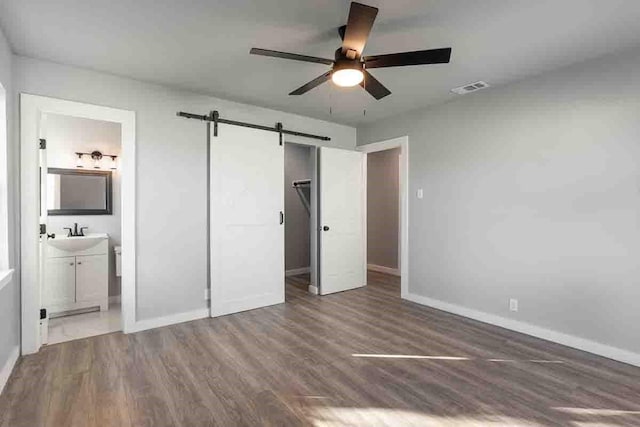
[284,143,317,299]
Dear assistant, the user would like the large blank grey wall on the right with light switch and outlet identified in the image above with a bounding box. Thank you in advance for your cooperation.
[358,49,640,364]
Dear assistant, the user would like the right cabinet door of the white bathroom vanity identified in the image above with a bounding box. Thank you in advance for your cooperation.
[76,255,109,302]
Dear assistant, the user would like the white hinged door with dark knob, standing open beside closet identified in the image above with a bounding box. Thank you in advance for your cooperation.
[319,147,367,295]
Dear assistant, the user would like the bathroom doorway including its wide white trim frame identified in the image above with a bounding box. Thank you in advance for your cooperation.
[20,94,135,354]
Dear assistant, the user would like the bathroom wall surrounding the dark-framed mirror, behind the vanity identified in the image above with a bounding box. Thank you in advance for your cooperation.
[44,114,122,296]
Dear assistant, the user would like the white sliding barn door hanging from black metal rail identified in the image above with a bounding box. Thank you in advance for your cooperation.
[211,125,284,317]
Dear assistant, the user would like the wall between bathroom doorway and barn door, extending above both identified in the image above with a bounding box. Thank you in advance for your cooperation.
[14,57,356,320]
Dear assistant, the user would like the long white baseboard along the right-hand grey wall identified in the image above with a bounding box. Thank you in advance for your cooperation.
[405,293,640,366]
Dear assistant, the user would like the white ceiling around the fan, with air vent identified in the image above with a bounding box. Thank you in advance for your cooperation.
[0,0,640,125]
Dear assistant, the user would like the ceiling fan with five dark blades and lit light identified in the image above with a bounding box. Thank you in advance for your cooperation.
[250,2,451,99]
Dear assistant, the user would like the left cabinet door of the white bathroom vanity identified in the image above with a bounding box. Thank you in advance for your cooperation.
[44,257,76,307]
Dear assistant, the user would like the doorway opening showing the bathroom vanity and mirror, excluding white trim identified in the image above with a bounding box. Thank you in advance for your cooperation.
[40,113,122,344]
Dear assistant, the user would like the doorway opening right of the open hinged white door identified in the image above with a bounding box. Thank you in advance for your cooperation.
[367,147,401,296]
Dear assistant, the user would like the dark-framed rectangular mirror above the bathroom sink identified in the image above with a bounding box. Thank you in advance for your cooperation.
[47,168,112,215]
